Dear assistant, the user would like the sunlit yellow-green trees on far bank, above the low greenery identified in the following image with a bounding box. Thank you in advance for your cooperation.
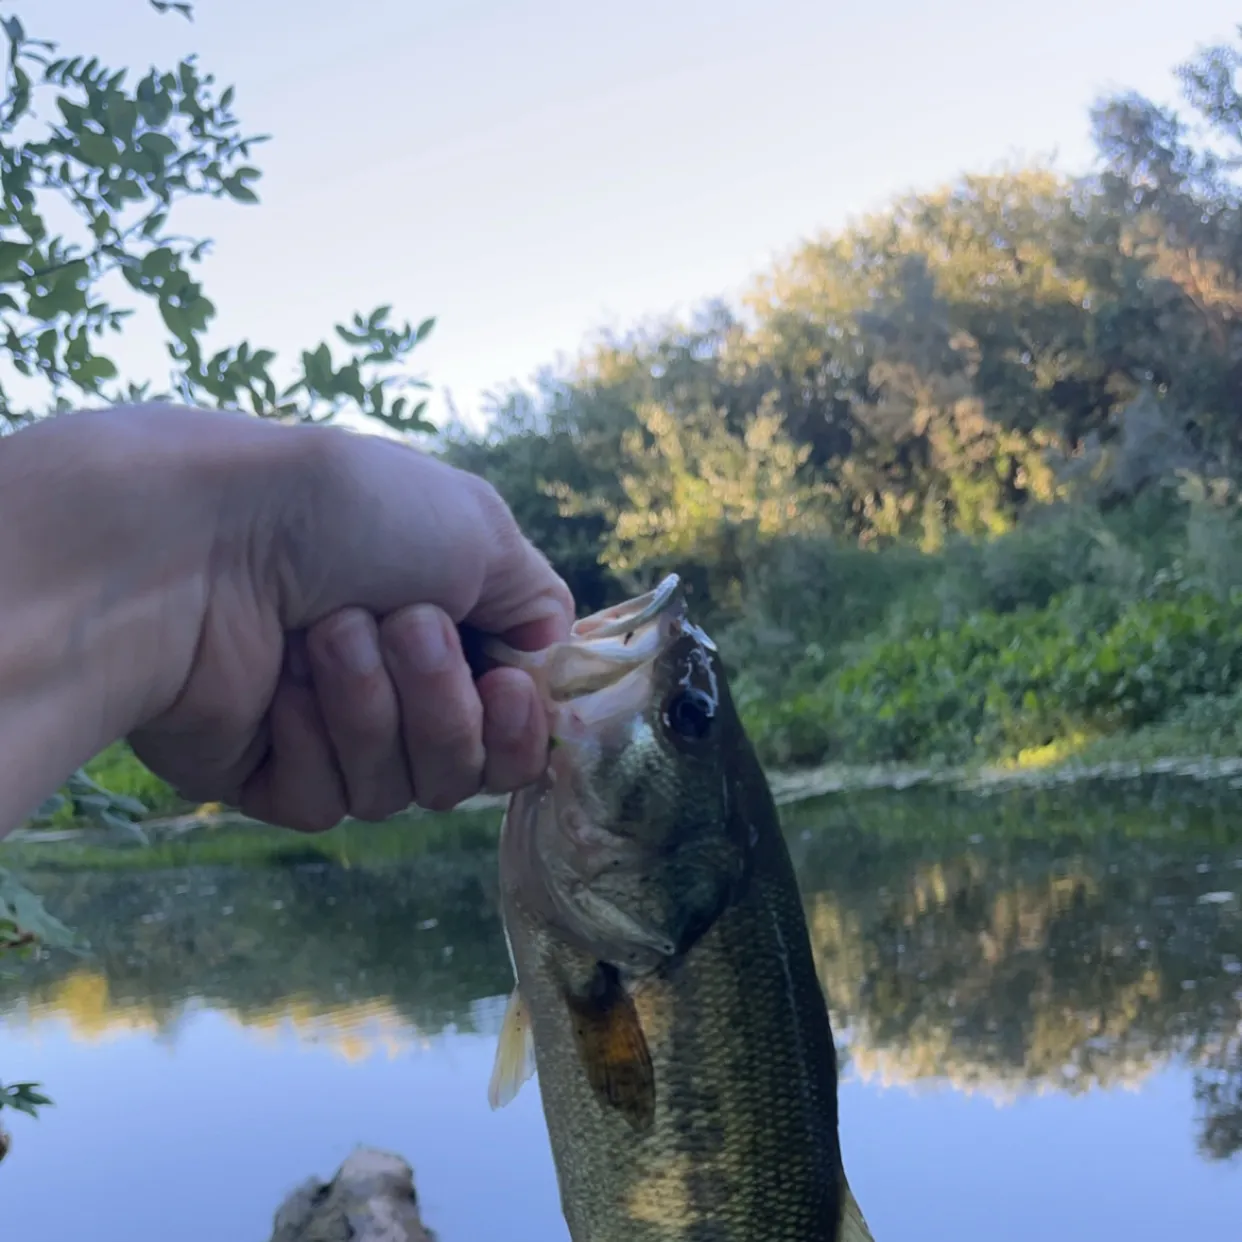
[446,24,1242,607]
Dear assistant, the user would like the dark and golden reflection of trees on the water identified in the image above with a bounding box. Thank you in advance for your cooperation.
[0,785,1242,1223]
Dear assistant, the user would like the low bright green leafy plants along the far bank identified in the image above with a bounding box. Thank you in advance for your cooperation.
[739,581,1242,764]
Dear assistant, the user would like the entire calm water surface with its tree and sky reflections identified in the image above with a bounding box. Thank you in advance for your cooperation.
[0,782,1242,1242]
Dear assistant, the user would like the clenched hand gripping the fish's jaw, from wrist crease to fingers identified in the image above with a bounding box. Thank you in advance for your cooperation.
[132,411,573,831]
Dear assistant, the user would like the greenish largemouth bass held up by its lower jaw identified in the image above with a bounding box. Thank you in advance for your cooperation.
[487,574,873,1242]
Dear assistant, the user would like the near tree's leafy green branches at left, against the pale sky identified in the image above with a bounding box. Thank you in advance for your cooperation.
[0,0,444,1117]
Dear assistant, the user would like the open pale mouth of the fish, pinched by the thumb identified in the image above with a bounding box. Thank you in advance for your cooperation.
[484,574,688,704]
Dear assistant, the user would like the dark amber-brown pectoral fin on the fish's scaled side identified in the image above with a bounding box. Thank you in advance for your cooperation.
[566,964,656,1133]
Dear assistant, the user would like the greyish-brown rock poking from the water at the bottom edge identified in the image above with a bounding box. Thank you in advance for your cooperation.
[272,1148,435,1242]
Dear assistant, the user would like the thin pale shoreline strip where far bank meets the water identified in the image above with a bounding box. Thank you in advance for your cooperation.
[7,755,1242,847]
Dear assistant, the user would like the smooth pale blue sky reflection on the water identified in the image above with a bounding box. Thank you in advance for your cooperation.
[0,1012,1242,1242]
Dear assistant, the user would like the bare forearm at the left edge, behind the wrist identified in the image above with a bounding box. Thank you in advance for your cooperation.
[0,414,218,836]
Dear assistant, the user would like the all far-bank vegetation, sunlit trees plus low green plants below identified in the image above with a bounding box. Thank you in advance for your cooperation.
[445,29,1242,765]
